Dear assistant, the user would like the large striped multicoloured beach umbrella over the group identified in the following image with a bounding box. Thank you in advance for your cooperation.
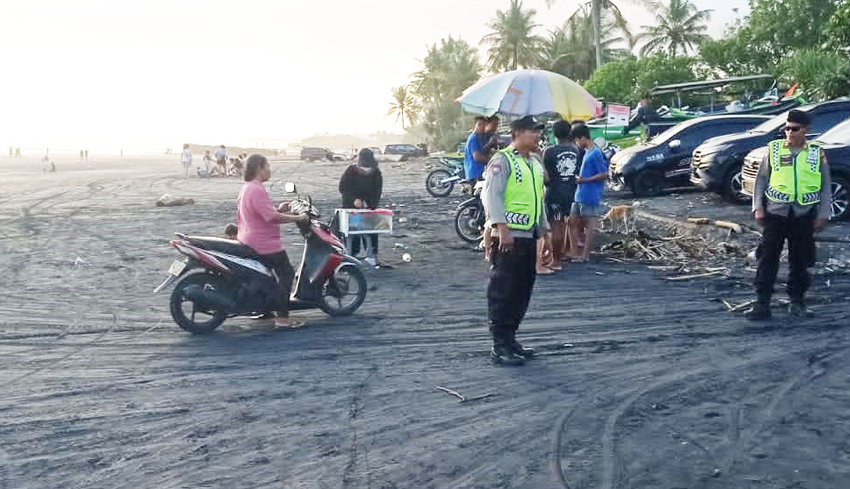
[457,70,602,121]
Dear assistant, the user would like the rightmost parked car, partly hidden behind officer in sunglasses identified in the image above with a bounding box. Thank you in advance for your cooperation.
[741,119,850,219]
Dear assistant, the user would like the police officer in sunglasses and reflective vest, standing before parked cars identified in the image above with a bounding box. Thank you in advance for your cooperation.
[744,110,832,320]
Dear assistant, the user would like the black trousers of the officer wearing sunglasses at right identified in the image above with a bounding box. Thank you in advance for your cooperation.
[755,214,815,302]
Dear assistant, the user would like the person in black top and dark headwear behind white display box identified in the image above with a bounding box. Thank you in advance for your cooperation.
[339,148,384,266]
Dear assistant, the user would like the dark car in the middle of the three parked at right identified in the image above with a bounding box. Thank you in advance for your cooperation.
[691,97,850,204]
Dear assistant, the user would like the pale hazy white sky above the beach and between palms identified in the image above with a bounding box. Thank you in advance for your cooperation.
[0,0,747,152]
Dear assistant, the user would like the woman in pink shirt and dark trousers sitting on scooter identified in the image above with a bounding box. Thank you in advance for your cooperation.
[236,154,309,328]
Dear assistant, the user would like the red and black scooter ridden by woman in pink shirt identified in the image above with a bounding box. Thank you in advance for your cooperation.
[154,183,366,333]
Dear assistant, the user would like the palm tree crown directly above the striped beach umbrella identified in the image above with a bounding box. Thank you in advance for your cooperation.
[481,0,540,71]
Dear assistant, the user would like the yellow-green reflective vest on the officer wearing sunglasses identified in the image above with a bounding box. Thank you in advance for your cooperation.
[764,139,822,205]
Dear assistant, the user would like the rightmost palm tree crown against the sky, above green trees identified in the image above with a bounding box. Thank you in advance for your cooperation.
[638,0,711,56]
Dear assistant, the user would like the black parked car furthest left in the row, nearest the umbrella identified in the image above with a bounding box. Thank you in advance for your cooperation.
[609,115,770,196]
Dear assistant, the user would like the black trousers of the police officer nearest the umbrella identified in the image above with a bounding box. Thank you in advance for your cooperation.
[487,237,537,343]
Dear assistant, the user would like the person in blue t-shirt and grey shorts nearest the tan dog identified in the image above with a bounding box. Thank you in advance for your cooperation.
[570,125,608,262]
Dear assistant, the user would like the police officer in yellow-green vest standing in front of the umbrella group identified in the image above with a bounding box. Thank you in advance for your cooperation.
[482,116,551,365]
